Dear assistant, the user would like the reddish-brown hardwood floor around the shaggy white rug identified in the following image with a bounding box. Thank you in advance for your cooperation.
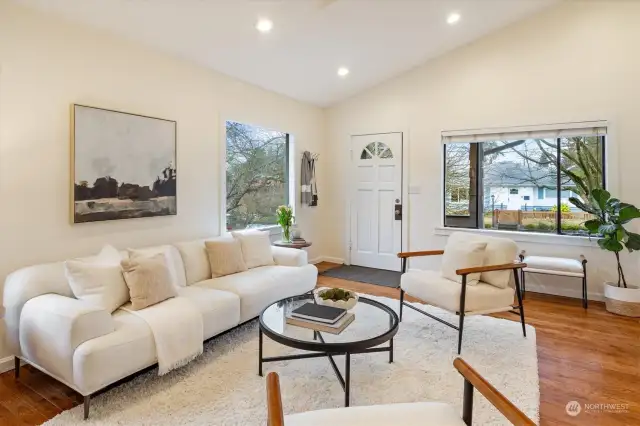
[0,262,640,426]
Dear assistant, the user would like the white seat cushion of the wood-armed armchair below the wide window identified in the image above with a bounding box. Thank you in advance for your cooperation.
[400,271,514,312]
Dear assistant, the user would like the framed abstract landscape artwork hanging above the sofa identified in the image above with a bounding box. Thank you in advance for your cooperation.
[71,104,177,223]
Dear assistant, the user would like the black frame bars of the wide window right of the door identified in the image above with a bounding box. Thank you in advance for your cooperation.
[442,135,607,237]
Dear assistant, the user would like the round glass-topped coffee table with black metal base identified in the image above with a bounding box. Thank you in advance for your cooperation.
[258,294,399,407]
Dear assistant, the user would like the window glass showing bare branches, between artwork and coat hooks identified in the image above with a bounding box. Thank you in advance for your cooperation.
[226,121,289,230]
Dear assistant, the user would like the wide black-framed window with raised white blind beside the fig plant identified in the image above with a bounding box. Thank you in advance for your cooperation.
[443,123,606,235]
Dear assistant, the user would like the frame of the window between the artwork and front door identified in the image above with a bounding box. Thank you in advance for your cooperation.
[218,117,296,236]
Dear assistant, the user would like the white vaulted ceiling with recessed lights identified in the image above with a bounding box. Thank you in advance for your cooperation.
[15,0,556,106]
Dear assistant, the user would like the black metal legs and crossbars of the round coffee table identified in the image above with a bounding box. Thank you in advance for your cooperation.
[258,329,393,407]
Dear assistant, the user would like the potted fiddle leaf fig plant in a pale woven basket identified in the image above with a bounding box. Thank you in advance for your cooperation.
[569,188,640,317]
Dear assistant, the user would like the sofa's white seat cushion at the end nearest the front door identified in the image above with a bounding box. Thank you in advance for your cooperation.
[195,265,318,322]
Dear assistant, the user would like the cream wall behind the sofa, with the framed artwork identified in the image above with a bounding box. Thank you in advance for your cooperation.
[0,0,328,357]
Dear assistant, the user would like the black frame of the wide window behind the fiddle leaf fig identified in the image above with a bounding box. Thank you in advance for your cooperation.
[442,134,608,237]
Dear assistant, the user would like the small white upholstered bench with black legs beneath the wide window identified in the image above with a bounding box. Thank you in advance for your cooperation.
[520,250,587,309]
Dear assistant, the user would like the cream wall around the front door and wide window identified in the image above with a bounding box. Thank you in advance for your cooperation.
[327,1,640,295]
